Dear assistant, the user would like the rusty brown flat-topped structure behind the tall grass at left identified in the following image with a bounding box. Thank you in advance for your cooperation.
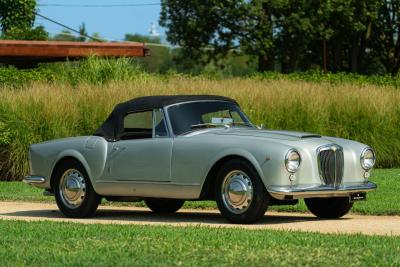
[0,40,149,67]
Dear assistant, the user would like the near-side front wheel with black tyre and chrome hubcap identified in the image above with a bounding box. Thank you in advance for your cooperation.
[215,159,269,224]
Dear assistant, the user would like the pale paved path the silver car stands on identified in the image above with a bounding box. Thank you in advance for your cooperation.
[0,202,400,236]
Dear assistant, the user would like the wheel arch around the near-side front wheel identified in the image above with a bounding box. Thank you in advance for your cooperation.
[200,153,265,199]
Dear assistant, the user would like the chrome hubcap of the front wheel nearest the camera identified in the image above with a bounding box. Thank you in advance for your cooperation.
[221,170,253,214]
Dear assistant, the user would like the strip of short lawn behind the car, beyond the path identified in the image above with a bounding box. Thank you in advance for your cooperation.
[0,169,400,218]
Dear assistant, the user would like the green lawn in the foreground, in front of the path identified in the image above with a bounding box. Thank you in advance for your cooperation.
[0,220,400,266]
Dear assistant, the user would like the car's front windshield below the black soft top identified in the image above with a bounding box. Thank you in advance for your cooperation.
[168,101,254,135]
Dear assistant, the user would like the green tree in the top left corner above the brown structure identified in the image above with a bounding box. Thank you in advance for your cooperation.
[0,0,48,40]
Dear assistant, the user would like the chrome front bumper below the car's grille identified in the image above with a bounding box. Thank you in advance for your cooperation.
[267,182,377,200]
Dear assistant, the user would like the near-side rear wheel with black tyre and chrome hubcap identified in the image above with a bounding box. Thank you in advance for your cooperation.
[54,159,101,218]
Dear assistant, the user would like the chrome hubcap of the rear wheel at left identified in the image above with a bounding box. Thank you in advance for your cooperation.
[59,169,86,209]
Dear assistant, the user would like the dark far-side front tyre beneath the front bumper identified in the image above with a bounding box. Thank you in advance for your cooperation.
[304,197,353,219]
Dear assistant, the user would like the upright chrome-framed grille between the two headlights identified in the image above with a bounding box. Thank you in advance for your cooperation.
[318,145,344,186]
